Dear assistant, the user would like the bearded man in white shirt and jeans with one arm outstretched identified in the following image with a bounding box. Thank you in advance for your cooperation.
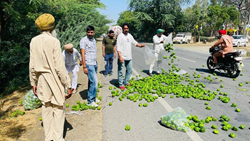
[117,23,145,90]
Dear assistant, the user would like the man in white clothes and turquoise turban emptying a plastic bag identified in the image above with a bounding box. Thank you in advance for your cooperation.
[149,29,167,76]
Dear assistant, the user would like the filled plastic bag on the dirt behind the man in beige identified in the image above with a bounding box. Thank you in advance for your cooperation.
[23,90,42,110]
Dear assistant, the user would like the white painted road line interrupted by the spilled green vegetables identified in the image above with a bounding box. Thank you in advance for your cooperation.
[132,68,203,141]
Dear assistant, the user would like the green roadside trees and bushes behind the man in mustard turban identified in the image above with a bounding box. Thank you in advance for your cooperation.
[0,0,111,94]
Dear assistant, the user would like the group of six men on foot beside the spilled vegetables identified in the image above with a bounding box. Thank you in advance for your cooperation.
[29,14,169,141]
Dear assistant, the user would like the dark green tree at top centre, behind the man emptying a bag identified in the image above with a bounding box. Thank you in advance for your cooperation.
[119,0,188,41]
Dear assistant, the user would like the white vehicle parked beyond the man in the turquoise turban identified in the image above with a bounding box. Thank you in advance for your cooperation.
[173,32,192,44]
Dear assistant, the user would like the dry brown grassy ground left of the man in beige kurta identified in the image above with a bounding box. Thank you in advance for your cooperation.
[0,91,40,141]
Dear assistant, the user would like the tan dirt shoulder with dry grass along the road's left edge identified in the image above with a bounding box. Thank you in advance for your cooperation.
[0,41,104,141]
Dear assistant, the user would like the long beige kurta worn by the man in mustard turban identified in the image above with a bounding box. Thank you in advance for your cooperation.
[29,32,71,106]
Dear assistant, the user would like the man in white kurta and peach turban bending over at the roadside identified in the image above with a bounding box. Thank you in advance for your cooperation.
[62,43,82,94]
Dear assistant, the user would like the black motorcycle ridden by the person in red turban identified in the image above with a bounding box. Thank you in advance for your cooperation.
[207,47,244,78]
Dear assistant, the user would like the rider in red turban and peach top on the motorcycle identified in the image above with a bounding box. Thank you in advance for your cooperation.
[210,30,234,68]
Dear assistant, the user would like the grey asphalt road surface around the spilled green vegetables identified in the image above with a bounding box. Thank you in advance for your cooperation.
[99,44,250,141]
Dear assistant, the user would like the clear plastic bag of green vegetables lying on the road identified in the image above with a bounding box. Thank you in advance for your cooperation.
[161,107,191,132]
